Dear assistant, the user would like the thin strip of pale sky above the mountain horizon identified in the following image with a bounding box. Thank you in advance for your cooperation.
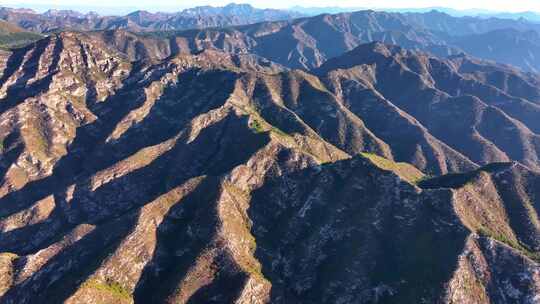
[0,0,540,12]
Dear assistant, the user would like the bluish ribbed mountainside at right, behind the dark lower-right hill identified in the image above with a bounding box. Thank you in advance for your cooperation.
[316,43,540,172]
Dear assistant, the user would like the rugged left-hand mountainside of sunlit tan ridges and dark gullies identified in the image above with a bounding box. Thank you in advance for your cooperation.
[0,34,347,303]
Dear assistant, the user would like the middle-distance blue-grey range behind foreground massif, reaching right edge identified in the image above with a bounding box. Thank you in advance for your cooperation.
[58,11,540,71]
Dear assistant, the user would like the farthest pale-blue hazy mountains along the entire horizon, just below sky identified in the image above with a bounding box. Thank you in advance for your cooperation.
[0,3,540,34]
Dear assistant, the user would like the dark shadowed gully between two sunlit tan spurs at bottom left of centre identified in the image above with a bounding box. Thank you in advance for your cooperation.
[134,177,220,303]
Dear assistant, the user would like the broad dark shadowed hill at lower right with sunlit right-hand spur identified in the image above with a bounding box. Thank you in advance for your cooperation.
[250,159,540,303]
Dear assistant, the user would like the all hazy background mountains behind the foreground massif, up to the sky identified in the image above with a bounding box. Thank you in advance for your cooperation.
[0,4,540,72]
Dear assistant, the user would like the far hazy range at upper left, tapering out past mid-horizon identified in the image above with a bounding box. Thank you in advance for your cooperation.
[0,4,302,33]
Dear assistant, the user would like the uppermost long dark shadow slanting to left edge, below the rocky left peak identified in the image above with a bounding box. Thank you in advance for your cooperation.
[0,66,240,217]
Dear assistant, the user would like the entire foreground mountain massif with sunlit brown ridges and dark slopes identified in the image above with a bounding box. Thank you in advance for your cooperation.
[0,33,540,303]
